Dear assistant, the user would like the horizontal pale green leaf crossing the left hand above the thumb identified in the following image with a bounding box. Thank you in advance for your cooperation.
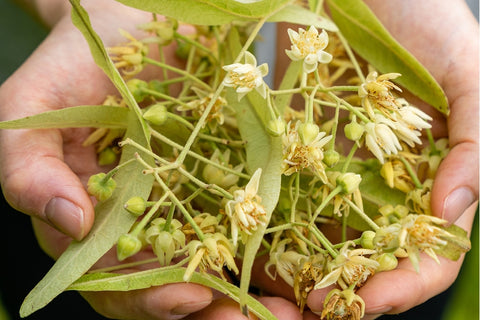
[0,106,130,129]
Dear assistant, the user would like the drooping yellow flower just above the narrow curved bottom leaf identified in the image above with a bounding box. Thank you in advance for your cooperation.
[183,233,238,282]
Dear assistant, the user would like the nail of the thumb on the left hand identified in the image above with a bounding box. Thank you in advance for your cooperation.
[45,197,84,240]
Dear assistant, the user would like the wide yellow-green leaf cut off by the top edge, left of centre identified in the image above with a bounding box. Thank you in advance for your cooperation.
[117,0,292,25]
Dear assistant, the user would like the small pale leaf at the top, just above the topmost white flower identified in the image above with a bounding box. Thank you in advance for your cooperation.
[267,4,338,32]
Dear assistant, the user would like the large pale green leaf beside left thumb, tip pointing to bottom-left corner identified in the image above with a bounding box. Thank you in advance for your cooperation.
[20,113,153,317]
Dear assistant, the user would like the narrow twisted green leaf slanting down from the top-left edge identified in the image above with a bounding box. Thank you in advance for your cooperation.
[70,0,149,136]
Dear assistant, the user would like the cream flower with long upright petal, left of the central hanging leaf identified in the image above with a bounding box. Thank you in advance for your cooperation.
[225,168,267,246]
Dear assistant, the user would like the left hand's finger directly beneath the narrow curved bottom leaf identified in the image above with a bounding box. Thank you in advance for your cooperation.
[82,283,212,320]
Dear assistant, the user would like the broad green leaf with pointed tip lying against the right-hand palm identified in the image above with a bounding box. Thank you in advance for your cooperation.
[327,0,449,115]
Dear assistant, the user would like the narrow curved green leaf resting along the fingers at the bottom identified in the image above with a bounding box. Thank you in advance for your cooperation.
[69,268,276,320]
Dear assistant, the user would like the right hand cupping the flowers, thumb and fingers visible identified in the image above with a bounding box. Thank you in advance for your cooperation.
[308,0,479,319]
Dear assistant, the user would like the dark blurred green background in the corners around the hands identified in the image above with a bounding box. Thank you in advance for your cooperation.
[0,0,479,320]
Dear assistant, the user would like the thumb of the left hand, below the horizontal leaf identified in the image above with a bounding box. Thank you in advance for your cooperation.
[0,130,94,240]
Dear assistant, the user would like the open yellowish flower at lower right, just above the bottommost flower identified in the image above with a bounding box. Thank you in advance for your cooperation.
[315,241,379,289]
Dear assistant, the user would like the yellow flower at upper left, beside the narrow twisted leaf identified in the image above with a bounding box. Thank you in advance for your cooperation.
[107,30,148,77]
